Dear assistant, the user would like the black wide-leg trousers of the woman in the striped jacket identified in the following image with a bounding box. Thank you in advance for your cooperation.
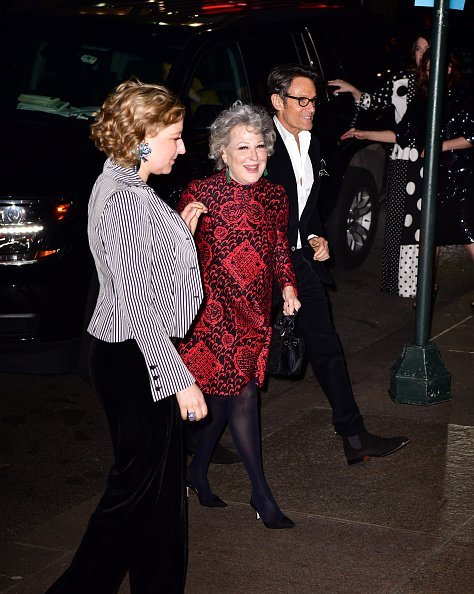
[47,339,186,594]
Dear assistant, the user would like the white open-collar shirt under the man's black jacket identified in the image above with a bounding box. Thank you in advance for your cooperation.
[273,116,314,249]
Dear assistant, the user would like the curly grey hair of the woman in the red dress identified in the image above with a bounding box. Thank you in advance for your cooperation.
[209,105,276,170]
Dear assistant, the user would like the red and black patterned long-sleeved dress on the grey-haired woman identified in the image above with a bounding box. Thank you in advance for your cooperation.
[178,171,296,396]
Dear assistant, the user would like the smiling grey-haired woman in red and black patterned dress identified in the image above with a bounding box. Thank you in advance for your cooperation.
[178,105,300,528]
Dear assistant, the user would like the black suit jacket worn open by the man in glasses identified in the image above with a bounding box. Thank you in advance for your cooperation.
[267,130,333,284]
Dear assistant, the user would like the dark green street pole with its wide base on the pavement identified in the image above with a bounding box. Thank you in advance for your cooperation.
[389,0,451,405]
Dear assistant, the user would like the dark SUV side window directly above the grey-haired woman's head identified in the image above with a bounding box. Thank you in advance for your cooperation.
[187,44,249,128]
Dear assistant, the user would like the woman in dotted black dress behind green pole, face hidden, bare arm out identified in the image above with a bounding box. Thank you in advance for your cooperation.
[342,51,474,297]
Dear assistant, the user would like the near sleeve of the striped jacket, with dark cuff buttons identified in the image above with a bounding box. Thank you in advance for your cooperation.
[101,192,194,400]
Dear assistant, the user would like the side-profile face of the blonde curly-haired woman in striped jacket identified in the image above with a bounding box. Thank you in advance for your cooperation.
[138,120,186,182]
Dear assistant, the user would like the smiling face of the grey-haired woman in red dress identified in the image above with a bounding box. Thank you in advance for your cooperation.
[222,124,268,185]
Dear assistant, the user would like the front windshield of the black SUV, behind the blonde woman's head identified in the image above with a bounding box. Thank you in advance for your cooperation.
[1,28,178,118]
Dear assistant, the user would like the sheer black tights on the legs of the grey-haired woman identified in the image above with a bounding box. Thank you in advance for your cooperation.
[189,380,282,522]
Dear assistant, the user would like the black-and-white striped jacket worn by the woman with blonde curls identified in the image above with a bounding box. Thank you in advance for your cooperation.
[88,159,203,400]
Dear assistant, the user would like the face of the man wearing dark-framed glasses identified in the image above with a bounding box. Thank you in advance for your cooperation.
[272,76,316,136]
